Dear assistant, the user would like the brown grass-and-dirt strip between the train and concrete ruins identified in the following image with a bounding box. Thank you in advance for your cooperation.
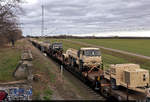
[25,40,104,100]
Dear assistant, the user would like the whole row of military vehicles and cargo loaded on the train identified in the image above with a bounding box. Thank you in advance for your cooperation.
[28,40,150,101]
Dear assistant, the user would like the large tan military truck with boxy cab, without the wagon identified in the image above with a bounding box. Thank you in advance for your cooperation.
[64,48,102,72]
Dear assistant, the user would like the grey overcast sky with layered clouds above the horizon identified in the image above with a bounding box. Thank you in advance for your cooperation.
[20,0,150,36]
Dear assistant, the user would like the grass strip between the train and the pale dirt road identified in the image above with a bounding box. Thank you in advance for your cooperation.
[37,39,150,70]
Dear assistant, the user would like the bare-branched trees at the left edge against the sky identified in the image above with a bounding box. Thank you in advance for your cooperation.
[0,0,22,46]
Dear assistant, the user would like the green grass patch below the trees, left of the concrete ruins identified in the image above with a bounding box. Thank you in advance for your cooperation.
[0,48,21,82]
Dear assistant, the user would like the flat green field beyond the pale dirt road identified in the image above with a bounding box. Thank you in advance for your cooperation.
[70,39,150,56]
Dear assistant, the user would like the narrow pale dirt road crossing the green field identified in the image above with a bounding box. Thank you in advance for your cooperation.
[65,39,150,60]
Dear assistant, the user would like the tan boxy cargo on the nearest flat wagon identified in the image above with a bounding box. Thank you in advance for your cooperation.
[104,64,149,88]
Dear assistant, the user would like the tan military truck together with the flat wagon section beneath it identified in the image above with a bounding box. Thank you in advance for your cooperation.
[64,47,102,85]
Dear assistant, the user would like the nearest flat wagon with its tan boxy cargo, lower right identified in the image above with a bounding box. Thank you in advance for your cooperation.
[103,63,150,101]
